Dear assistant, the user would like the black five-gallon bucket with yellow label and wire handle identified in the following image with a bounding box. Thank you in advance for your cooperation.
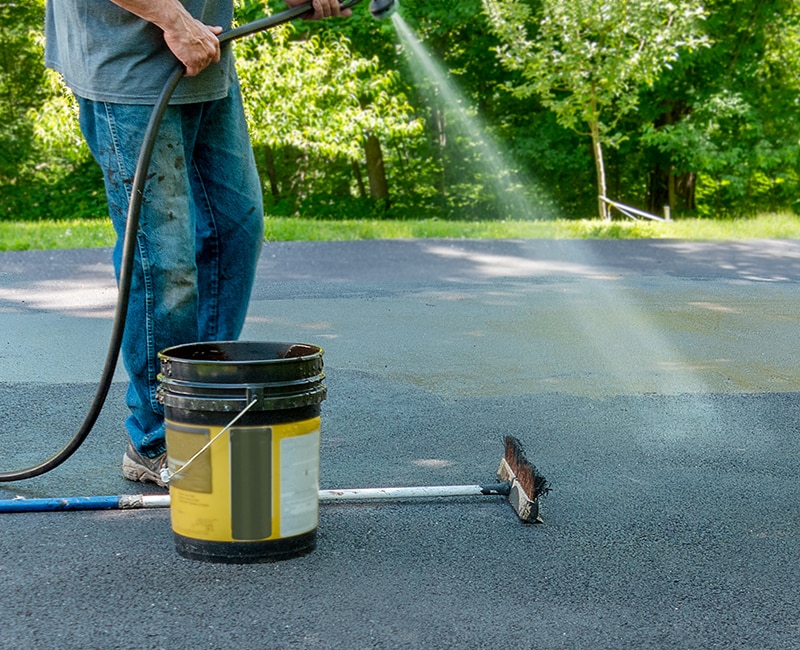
[159,341,326,562]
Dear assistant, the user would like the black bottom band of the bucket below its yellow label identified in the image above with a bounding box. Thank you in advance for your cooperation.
[174,530,317,564]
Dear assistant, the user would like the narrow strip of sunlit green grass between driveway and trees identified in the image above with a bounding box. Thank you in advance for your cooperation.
[0,214,800,251]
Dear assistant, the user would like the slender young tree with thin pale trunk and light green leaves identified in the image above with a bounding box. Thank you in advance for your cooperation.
[483,0,705,219]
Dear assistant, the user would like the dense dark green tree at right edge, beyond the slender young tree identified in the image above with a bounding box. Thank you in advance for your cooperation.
[641,0,800,216]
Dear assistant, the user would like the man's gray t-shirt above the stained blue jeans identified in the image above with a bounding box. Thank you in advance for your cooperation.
[45,0,235,104]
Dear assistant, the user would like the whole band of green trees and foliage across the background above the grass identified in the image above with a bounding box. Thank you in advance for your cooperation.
[0,0,800,224]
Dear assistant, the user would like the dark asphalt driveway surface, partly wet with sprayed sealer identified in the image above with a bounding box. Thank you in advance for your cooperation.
[0,240,800,649]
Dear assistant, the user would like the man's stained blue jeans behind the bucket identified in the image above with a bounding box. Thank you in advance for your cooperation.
[78,84,264,457]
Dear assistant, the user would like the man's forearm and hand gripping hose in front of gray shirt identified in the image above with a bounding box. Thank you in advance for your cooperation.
[111,0,222,77]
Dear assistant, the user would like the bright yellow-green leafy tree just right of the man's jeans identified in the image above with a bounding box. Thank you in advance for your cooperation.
[237,20,422,210]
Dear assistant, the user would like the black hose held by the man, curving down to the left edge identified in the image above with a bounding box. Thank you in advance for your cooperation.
[0,0,361,476]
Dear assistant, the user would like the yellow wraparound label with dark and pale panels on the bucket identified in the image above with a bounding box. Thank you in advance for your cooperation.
[166,417,320,542]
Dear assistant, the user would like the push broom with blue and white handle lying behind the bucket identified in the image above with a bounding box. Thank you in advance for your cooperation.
[0,436,551,523]
